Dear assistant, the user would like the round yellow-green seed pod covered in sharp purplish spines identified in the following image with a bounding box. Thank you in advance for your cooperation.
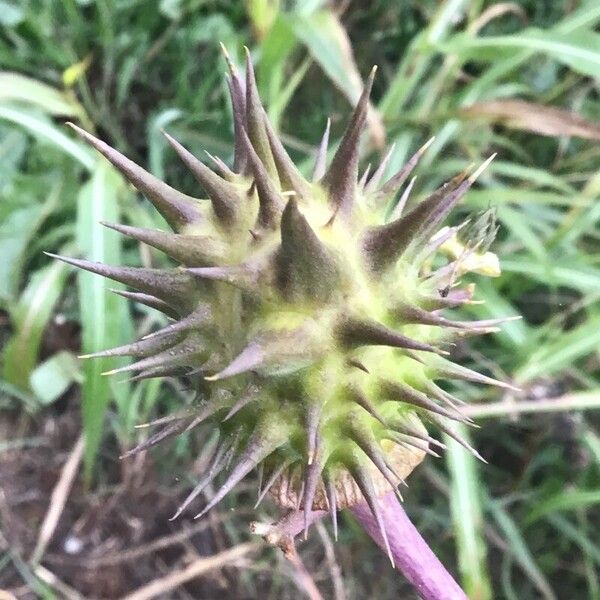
[49,47,509,556]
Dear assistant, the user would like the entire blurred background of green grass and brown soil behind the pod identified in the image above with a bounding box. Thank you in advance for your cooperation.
[0,0,600,600]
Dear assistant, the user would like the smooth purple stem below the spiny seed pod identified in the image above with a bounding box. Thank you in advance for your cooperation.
[350,492,468,600]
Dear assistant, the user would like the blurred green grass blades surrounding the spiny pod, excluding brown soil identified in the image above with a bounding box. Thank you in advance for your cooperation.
[0,0,600,599]
